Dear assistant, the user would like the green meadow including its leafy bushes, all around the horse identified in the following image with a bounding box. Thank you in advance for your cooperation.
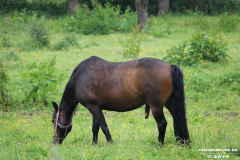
[0,1,240,159]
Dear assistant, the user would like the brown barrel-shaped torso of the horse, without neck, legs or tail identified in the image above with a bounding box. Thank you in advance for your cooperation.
[74,57,172,111]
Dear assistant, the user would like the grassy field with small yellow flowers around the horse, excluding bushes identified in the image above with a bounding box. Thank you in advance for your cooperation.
[0,12,240,159]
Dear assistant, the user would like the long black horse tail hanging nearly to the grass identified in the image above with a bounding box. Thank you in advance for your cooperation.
[171,65,189,143]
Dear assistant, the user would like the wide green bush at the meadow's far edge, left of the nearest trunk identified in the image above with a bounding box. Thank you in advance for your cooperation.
[65,1,137,34]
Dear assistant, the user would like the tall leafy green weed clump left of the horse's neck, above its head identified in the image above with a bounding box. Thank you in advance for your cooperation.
[20,57,63,106]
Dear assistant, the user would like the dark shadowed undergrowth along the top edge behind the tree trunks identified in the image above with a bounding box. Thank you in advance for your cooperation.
[0,0,240,16]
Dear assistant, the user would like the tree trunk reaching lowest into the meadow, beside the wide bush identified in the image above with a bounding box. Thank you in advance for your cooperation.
[135,0,149,30]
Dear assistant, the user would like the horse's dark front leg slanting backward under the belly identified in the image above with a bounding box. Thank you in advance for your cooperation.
[87,105,113,143]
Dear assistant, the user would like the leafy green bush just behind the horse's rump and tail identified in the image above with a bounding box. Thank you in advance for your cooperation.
[164,32,231,65]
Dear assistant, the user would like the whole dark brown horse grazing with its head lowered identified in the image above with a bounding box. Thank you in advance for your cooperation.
[52,56,189,144]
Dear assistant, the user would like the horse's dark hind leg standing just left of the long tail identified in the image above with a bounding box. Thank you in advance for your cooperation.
[151,106,167,145]
